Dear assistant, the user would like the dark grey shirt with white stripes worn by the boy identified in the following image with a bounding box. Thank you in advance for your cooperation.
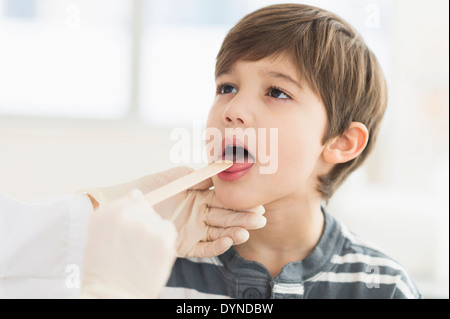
[160,209,421,299]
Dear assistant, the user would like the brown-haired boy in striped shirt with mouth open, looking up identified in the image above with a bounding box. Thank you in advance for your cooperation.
[161,4,421,298]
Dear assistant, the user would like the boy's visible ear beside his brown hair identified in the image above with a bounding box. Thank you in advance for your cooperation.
[322,122,369,164]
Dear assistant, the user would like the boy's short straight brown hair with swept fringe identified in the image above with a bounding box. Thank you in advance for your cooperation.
[216,4,387,200]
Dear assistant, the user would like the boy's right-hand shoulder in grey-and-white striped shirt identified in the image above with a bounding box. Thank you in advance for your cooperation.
[324,223,422,299]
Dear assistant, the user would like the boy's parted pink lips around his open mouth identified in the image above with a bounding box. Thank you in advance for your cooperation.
[217,136,255,181]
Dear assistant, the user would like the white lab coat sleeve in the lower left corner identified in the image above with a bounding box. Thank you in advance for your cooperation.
[0,192,94,298]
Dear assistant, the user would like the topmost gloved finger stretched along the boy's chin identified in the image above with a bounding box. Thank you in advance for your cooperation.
[205,208,267,229]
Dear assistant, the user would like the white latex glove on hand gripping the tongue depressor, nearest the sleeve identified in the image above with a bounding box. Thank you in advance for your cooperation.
[80,190,177,298]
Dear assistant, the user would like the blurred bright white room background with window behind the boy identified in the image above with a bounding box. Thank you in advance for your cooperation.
[0,0,449,298]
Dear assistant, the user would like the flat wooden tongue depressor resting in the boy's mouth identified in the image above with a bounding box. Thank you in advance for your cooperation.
[144,160,233,205]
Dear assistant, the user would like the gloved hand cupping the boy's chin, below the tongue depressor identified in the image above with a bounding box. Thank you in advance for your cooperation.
[154,174,266,257]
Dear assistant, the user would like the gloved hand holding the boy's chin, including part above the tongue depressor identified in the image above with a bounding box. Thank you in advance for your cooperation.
[79,167,266,257]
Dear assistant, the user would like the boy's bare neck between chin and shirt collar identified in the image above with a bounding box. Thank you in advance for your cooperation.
[236,198,324,276]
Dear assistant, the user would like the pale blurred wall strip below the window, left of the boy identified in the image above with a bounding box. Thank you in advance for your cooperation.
[0,117,202,200]
